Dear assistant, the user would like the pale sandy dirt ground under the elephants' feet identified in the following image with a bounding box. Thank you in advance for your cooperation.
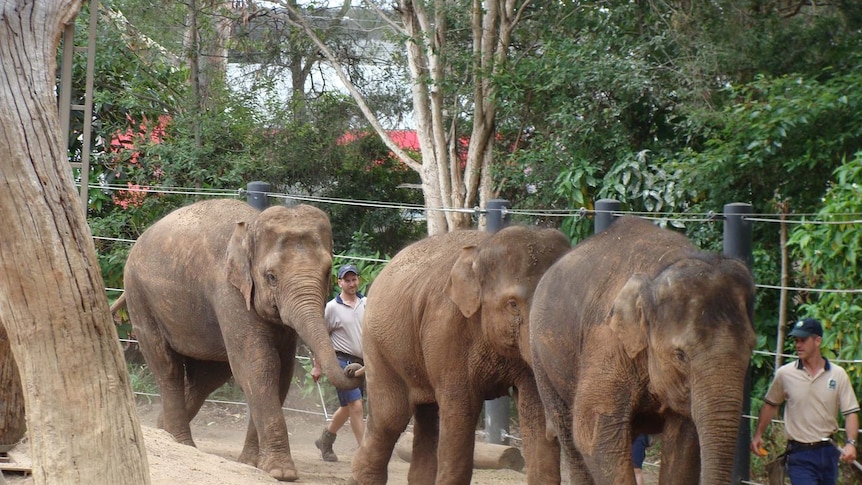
[3,397,657,485]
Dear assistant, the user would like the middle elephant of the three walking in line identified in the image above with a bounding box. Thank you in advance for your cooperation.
[352,226,570,484]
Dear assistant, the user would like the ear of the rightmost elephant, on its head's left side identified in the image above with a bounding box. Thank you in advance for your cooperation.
[609,273,650,359]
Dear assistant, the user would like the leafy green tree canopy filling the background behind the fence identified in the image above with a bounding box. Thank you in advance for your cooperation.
[70,0,862,416]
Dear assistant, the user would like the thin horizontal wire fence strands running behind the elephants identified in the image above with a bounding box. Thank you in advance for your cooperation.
[90,180,862,485]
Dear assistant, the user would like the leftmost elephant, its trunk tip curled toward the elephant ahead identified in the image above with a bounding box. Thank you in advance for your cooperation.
[124,200,361,481]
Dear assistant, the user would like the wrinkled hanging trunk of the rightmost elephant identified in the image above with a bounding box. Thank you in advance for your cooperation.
[692,361,747,485]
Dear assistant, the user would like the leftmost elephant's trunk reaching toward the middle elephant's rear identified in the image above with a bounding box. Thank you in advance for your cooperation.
[281,298,363,389]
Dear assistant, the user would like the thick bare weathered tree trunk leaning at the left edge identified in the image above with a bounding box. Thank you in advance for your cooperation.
[0,0,150,484]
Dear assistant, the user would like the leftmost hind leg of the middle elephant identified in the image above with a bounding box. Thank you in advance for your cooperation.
[351,358,413,485]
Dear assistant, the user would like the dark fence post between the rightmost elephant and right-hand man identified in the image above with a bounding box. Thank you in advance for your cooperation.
[723,202,754,483]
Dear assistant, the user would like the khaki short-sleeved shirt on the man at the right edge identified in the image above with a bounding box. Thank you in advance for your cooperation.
[764,360,859,443]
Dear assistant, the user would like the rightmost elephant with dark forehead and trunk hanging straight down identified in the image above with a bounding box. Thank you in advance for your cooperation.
[530,217,755,485]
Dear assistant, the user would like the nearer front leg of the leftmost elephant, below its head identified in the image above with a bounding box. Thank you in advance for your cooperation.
[230,330,299,482]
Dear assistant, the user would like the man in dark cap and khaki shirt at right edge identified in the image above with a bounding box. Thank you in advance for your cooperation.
[751,318,859,485]
